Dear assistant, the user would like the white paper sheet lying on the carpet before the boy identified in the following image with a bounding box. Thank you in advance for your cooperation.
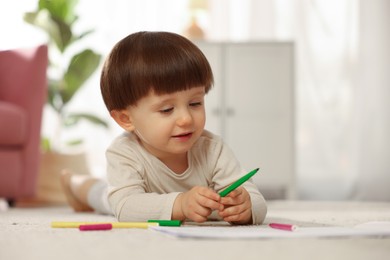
[149,222,390,239]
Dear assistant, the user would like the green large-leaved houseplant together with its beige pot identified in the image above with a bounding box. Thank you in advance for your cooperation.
[24,0,108,203]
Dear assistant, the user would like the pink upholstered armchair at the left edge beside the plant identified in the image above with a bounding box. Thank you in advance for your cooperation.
[0,45,48,202]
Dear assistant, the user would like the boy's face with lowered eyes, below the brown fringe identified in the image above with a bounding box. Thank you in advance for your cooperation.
[119,86,206,159]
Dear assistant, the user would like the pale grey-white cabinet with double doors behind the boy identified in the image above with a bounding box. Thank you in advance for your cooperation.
[196,42,295,199]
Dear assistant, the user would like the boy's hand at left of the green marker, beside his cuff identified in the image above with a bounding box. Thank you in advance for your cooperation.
[172,186,223,222]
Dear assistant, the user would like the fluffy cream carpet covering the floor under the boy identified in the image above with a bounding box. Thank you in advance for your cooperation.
[0,201,390,260]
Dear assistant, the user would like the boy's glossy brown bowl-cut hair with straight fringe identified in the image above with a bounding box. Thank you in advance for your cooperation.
[100,32,213,111]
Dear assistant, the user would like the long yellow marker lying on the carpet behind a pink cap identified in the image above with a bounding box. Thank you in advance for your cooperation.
[51,221,159,228]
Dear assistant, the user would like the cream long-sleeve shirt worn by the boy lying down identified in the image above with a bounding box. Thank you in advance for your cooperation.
[106,130,267,224]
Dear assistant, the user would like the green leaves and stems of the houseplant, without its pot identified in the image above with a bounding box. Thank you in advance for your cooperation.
[24,0,108,150]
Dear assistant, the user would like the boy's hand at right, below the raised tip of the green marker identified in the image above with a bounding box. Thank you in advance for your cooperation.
[219,187,252,224]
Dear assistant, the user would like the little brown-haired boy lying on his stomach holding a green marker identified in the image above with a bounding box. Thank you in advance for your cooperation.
[62,32,267,224]
